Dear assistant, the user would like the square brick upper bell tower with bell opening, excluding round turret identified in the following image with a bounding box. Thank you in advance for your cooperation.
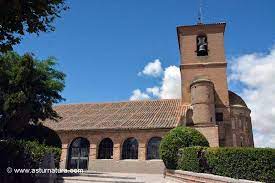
[177,23,229,107]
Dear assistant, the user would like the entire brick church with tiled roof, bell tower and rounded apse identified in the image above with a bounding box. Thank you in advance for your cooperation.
[45,22,254,173]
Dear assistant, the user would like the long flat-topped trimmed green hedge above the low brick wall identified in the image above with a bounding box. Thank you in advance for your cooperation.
[178,147,275,183]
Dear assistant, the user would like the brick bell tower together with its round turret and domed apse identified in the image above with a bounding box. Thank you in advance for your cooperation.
[177,21,253,146]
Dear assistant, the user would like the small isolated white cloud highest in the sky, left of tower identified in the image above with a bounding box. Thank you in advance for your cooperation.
[138,59,163,77]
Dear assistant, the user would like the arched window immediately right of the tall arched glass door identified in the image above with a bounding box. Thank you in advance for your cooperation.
[97,138,114,159]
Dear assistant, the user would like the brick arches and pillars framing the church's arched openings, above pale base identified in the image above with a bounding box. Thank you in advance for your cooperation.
[58,129,170,168]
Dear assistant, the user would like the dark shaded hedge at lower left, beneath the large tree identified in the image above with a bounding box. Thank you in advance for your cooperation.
[0,139,61,182]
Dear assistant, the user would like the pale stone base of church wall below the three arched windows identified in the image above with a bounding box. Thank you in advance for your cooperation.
[89,159,165,174]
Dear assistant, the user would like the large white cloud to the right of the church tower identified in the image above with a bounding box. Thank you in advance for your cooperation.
[229,48,275,147]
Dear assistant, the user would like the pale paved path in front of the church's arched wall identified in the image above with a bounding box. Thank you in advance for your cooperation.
[58,172,165,183]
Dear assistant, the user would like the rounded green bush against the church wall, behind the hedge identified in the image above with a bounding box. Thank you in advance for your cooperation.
[160,127,209,169]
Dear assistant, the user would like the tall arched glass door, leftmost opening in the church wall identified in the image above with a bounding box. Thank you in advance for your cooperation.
[68,137,90,169]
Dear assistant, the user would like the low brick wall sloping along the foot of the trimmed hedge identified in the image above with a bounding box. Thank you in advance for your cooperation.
[165,170,260,183]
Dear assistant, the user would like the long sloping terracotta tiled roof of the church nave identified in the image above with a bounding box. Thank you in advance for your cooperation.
[44,99,187,131]
